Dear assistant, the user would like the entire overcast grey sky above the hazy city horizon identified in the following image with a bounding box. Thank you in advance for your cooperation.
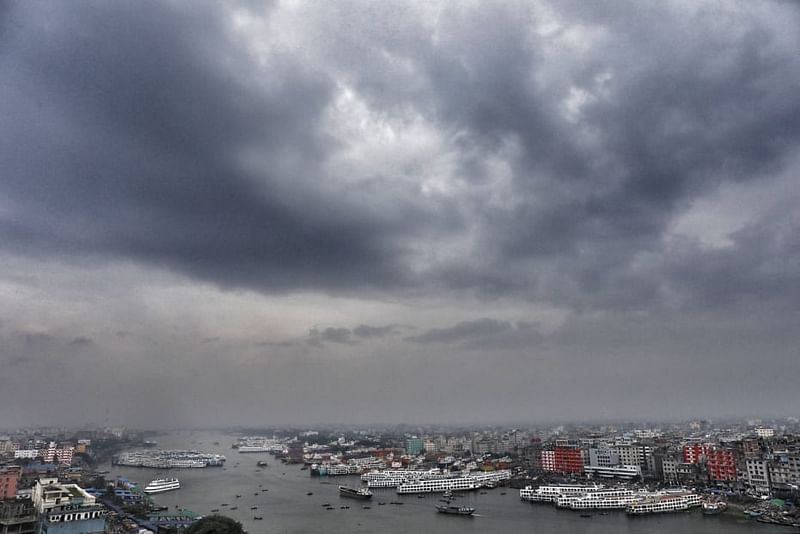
[0,0,800,427]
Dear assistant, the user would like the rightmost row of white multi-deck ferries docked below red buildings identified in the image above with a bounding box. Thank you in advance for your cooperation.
[519,484,702,515]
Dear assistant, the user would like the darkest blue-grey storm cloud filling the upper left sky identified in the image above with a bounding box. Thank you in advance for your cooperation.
[0,3,434,289]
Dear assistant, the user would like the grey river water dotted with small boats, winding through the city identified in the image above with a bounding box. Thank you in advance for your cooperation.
[103,432,780,534]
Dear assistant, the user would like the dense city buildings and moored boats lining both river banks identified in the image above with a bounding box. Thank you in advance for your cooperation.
[0,418,800,534]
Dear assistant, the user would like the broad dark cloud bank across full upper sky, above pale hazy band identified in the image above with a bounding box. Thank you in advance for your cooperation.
[0,2,800,310]
